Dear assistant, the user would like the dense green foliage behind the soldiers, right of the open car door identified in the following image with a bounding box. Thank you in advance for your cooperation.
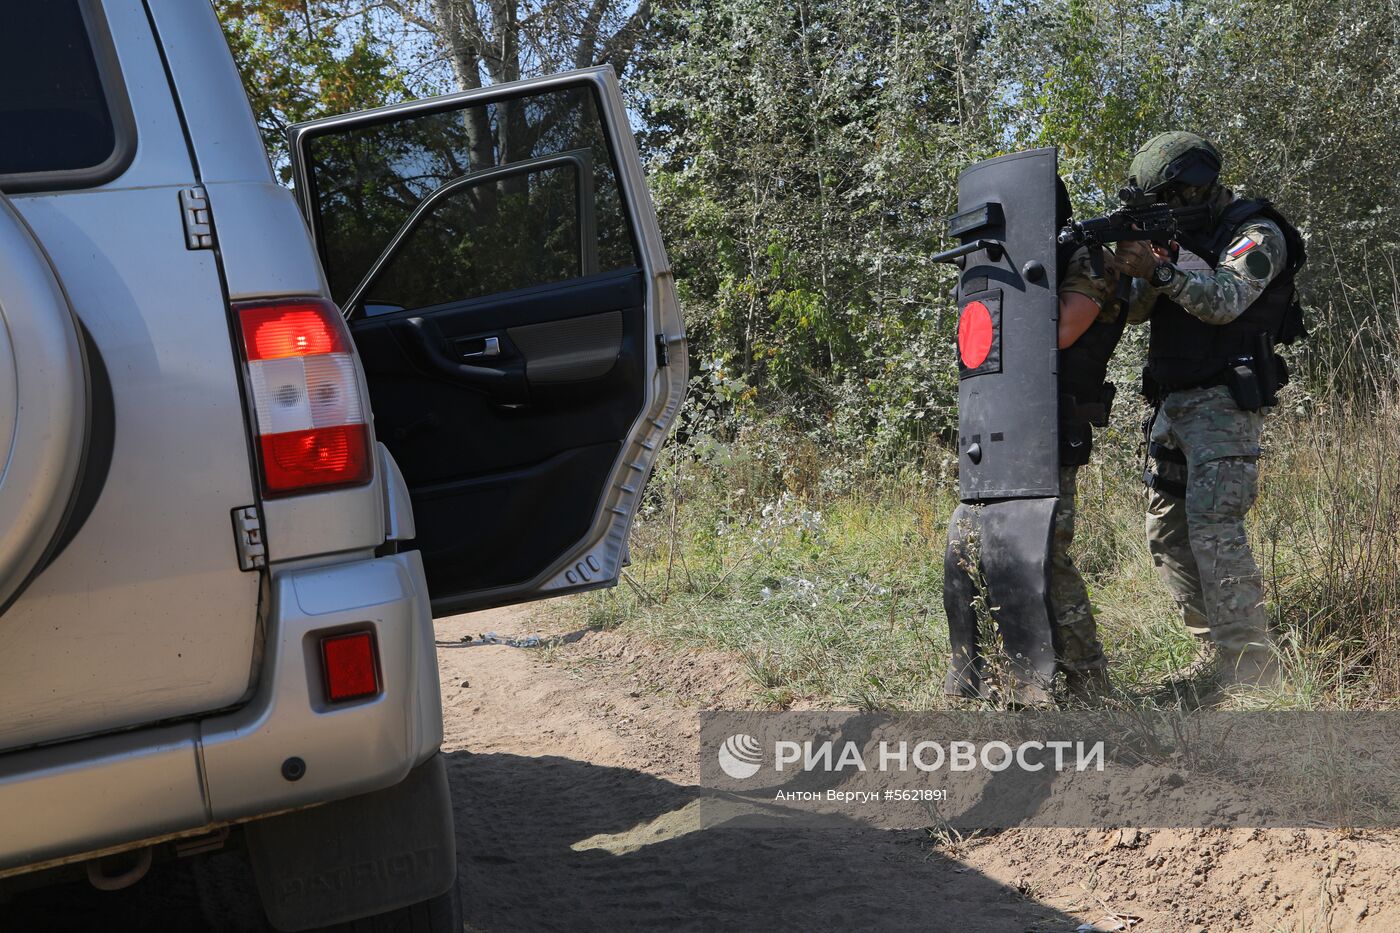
[640,0,1400,461]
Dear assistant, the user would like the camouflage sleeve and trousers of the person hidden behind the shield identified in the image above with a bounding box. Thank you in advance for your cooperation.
[1050,248,1113,672]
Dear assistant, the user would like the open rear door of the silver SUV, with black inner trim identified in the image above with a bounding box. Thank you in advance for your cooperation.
[290,67,686,615]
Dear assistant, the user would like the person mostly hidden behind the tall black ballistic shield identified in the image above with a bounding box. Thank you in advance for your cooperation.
[1050,179,1124,699]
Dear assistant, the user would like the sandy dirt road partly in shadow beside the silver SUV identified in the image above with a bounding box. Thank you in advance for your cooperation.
[438,609,1400,933]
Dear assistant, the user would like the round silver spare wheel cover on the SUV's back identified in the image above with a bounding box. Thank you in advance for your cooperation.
[0,195,90,612]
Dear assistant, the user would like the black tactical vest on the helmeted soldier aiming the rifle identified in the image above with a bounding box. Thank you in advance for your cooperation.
[1147,199,1308,392]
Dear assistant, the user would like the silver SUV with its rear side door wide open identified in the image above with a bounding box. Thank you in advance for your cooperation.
[0,0,686,930]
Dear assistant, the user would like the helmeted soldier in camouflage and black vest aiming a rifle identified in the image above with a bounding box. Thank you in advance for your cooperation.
[1109,133,1305,688]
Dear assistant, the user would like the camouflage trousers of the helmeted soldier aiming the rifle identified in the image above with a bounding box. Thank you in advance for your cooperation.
[1147,385,1268,651]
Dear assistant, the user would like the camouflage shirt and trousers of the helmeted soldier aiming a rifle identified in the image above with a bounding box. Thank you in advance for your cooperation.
[1128,192,1287,654]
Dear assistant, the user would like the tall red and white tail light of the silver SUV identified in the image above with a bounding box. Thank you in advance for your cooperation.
[234,298,372,496]
